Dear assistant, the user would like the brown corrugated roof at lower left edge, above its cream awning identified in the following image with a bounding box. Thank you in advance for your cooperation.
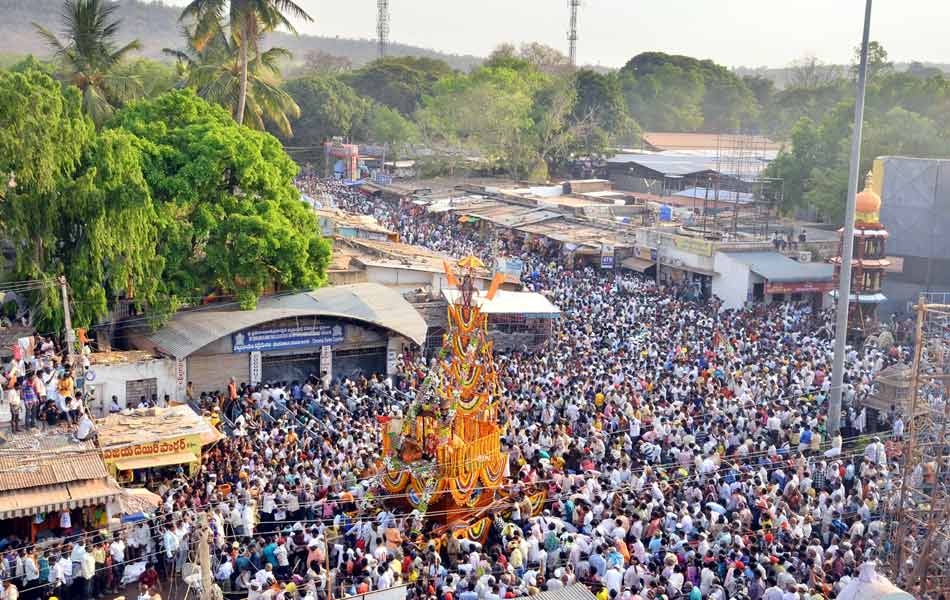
[0,433,108,491]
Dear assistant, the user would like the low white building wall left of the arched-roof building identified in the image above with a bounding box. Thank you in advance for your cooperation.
[86,358,178,415]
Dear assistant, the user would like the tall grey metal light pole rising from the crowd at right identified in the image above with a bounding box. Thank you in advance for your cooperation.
[827,0,871,436]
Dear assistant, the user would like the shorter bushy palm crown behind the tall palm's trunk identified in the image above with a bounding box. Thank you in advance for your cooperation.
[162,27,300,137]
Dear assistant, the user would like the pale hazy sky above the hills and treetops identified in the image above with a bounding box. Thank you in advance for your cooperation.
[166,0,950,67]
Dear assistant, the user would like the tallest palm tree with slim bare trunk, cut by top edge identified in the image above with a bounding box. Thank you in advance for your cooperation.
[181,0,313,123]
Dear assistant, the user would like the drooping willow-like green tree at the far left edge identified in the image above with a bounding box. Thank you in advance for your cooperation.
[0,71,162,330]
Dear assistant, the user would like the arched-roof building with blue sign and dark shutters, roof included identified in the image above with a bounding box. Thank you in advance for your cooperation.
[133,283,426,393]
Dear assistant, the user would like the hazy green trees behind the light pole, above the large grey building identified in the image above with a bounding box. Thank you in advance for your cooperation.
[766,42,950,223]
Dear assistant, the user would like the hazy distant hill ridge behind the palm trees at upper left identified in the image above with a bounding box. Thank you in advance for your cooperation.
[0,0,482,71]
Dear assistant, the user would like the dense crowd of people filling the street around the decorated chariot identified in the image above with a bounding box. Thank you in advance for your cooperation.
[0,179,939,600]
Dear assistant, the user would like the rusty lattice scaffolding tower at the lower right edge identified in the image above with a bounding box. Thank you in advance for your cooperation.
[884,294,950,598]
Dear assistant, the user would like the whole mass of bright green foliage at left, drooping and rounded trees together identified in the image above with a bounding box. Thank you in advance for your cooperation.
[0,70,330,330]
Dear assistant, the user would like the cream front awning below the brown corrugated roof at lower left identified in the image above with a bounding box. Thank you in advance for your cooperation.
[0,480,122,520]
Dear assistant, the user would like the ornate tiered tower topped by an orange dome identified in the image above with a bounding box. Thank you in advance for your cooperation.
[831,172,890,336]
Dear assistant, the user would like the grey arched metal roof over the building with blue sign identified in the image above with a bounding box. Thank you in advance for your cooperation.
[148,283,426,358]
